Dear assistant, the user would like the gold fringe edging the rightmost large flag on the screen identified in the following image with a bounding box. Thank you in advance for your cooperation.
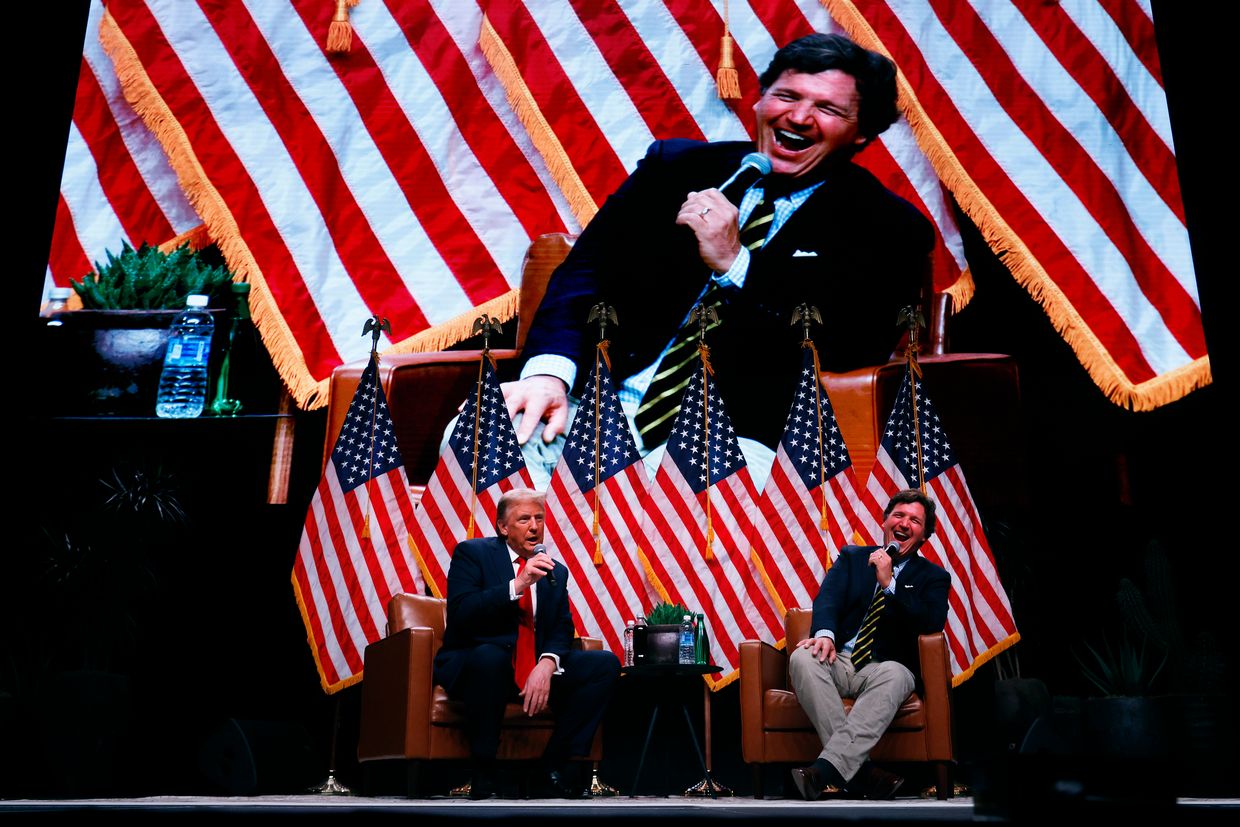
[818,0,1213,410]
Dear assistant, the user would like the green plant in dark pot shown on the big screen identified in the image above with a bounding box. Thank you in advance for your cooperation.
[50,243,232,415]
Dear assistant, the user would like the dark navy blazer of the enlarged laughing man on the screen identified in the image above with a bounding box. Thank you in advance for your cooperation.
[522,140,934,445]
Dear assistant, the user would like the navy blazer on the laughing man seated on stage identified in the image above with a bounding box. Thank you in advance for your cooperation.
[810,546,951,676]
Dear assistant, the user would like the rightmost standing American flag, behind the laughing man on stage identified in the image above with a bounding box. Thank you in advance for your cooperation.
[863,361,1021,684]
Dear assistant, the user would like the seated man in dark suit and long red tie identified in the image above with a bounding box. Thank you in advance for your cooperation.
[435,489,620,798]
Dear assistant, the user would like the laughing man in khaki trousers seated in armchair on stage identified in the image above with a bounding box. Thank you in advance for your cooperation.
[789,489,951,801]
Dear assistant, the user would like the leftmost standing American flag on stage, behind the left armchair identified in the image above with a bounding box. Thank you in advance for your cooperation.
[293,360,423,692]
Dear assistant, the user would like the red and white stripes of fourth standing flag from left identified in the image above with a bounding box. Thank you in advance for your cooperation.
[641,463,784,689]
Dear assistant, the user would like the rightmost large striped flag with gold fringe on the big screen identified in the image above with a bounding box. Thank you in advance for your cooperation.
[848,0,1209,408]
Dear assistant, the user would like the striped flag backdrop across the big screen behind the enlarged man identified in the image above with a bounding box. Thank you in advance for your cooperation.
[47,0,1209,408]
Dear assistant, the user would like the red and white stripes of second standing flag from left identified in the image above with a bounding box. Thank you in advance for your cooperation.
[409,448,534,598]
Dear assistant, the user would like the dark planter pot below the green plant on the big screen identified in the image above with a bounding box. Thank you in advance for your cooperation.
[47,310,218,417]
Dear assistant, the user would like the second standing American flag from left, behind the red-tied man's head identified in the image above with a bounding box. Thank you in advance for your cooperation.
[409,355,533,598]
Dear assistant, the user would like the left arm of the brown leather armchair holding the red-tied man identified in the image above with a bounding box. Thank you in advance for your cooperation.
[357,626,435,761]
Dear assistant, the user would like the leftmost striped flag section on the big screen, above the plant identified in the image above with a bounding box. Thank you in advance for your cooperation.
[45,0,202,301]
